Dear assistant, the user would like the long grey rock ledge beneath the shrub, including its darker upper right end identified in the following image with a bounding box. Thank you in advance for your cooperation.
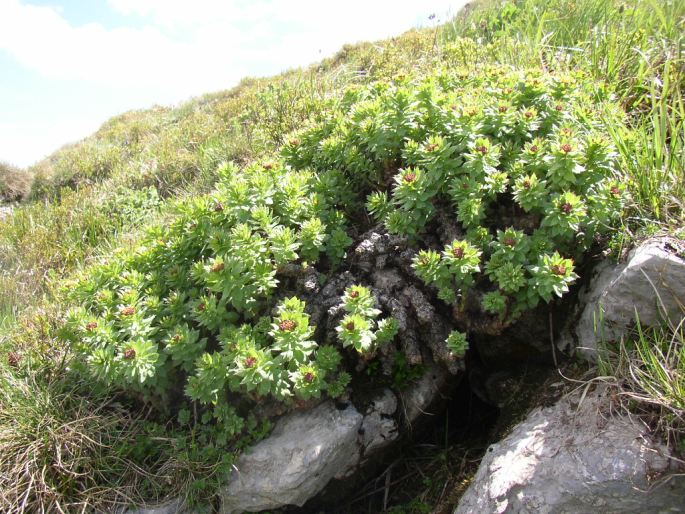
[220,365,450,514]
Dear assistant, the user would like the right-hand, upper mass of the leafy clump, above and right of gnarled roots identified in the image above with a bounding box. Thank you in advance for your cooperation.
[284,67,624,322]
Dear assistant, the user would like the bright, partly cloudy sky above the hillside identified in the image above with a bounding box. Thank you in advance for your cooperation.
[0,0,466,166]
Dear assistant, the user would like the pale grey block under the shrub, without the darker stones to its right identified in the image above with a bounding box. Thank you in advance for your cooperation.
[220,401,362,514]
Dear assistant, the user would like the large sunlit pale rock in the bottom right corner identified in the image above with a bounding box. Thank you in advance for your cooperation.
[455,384,685,514]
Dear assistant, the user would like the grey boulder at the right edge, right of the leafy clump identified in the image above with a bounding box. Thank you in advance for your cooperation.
[561,237,685,360]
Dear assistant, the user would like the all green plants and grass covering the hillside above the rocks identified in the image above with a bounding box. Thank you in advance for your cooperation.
[0,0,685,512]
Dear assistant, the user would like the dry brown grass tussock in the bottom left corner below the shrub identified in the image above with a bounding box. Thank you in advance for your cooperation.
[0,360,172,514]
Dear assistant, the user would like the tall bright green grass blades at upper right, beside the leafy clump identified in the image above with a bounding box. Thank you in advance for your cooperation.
[445,0,685,229]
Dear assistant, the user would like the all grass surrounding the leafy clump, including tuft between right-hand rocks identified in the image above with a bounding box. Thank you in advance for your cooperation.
[0,0,685,512]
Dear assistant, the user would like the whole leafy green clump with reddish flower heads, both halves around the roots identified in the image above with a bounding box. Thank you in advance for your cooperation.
[64,68,623,450]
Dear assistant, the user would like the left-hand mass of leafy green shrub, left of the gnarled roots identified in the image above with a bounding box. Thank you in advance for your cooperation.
[64,162,350,432]
